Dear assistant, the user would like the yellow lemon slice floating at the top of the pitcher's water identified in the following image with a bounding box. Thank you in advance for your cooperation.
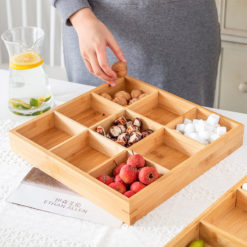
[9,52,43,70]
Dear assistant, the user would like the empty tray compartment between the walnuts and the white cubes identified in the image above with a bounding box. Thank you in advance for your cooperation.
[129,90,195,125]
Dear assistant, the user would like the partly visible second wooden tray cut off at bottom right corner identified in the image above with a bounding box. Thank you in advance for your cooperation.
[165,176,247,247]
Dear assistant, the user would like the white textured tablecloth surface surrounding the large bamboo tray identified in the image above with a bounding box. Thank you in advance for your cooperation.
[0,70,247,247]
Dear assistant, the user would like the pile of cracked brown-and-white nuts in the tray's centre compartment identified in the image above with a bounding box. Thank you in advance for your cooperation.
[96,116,153,147]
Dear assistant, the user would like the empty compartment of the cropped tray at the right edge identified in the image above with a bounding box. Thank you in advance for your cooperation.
[203,189,247,246]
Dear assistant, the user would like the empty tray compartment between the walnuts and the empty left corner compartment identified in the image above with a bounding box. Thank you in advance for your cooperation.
[58,93,122,127]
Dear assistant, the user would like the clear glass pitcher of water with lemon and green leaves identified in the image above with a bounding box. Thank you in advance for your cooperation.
[1,27,54,116]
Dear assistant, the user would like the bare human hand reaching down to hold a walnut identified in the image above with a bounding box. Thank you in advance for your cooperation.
[70,8,126,86]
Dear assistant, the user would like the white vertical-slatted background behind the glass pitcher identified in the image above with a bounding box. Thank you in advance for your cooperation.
[0,0,66,79]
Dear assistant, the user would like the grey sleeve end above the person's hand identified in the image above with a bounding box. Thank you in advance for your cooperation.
[51,0,91,26]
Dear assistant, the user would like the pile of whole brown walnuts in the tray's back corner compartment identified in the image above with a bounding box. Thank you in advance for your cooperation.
[100,89,147,106]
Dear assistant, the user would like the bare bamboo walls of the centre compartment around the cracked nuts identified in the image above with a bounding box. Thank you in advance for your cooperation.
[91,109,162,149]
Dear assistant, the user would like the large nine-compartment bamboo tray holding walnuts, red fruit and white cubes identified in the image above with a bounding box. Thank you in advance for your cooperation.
[9,62,244,224]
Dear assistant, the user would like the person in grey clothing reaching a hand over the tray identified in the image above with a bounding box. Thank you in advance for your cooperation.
[52,0,221,106]
